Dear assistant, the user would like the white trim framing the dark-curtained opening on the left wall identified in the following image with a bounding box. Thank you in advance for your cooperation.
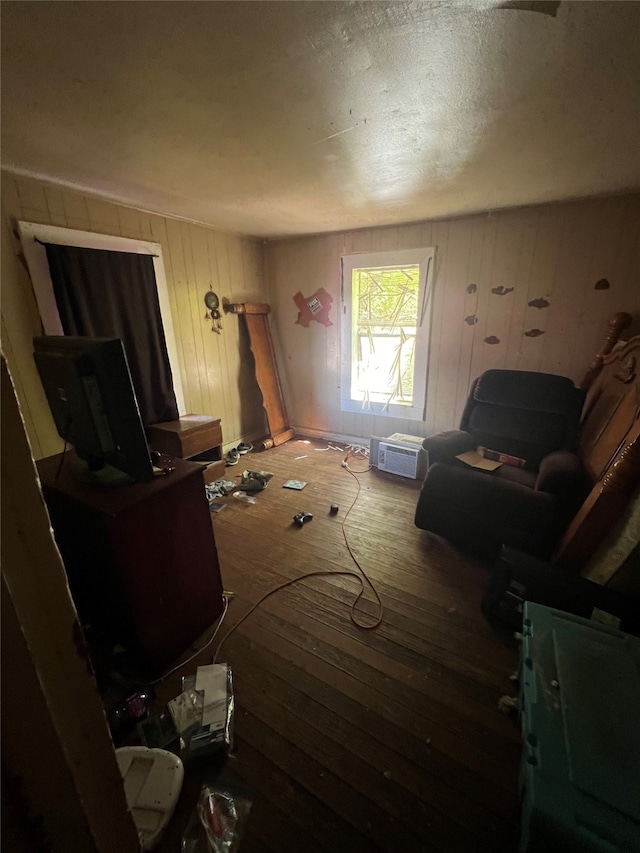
[18,222,186,415]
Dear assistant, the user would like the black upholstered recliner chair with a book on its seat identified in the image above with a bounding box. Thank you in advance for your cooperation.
[415,370,587,558]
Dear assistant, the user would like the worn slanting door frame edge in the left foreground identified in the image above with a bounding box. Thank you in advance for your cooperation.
[1,358,139,853]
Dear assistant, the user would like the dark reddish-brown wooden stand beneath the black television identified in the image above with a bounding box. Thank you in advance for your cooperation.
[37,451,223,671]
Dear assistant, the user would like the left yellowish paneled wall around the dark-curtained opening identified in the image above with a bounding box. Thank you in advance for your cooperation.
[2,173,269,459]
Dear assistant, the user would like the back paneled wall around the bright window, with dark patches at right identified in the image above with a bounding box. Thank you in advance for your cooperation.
[267,194,640,437]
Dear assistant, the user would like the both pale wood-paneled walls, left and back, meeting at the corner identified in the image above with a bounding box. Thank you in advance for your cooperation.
[2,173,640,458]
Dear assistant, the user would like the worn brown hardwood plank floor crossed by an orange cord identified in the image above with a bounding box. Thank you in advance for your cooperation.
[158,439,520,853]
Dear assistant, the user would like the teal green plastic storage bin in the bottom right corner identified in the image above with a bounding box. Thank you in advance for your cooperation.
[518,602,640,853]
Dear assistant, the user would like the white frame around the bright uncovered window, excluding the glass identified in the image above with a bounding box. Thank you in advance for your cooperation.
[340,248,435,421]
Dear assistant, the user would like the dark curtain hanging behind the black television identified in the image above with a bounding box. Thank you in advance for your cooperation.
[45,243,179,426]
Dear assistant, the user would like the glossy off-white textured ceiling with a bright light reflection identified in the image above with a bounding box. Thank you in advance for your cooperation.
[2,0,640,236]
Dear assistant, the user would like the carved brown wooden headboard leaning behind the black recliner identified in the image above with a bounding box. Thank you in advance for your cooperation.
[553,315,640,571]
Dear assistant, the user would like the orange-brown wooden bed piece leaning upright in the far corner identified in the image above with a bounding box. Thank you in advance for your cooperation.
[224,302,294,450]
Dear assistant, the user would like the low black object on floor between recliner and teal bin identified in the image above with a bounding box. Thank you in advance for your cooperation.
[482,548,640,636]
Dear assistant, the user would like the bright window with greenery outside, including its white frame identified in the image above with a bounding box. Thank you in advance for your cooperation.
[341,249,434,420]
